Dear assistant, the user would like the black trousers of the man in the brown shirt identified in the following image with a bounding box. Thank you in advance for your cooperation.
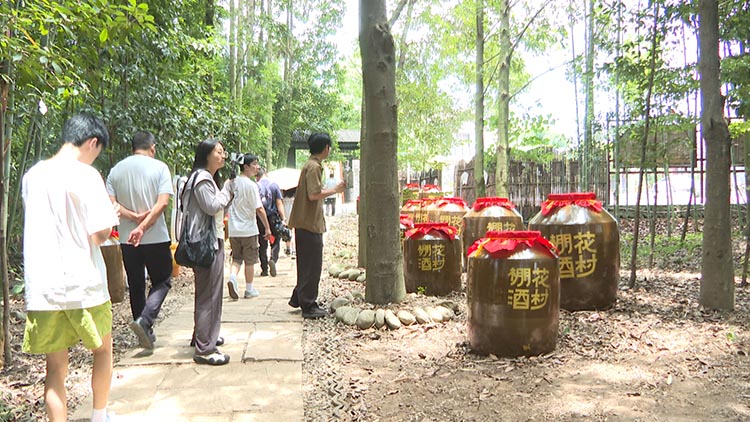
[292,229,323,311]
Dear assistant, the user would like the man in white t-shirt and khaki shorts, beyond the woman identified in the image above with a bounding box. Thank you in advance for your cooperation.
[227,154,271,300]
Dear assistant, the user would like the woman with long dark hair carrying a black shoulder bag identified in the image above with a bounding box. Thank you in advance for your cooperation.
[178,138,233,365]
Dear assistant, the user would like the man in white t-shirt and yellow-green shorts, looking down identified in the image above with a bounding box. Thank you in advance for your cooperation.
[21,113,120,422]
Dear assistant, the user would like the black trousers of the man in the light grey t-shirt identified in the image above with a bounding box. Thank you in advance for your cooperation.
[120,242,172,327]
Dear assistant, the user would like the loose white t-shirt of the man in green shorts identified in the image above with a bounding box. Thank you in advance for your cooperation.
[22,158,118,311]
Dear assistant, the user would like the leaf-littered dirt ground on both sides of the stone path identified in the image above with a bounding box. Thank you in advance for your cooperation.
[0,216,750,421]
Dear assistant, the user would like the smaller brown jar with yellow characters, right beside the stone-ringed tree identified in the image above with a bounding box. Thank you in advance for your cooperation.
[404,223,461,296]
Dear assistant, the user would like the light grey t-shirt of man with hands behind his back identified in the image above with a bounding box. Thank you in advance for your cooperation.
[107,154,174,245]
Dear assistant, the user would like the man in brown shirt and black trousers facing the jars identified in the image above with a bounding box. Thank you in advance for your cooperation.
[289,133,346,318]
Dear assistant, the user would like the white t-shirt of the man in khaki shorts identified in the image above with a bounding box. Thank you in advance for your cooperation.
[229,175,263,237]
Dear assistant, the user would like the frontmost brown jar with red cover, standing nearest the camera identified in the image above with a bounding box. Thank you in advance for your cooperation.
[466,231,560,357]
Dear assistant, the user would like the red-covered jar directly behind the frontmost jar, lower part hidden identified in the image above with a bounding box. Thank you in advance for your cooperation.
[461,197,524,255]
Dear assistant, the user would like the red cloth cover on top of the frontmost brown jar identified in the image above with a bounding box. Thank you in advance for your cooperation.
[467,230,557,258]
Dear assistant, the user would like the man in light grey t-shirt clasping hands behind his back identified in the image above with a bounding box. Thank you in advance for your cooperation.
[107,131,174,349]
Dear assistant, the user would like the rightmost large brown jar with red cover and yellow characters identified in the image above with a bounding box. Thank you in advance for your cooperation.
[529,192,620,311]
